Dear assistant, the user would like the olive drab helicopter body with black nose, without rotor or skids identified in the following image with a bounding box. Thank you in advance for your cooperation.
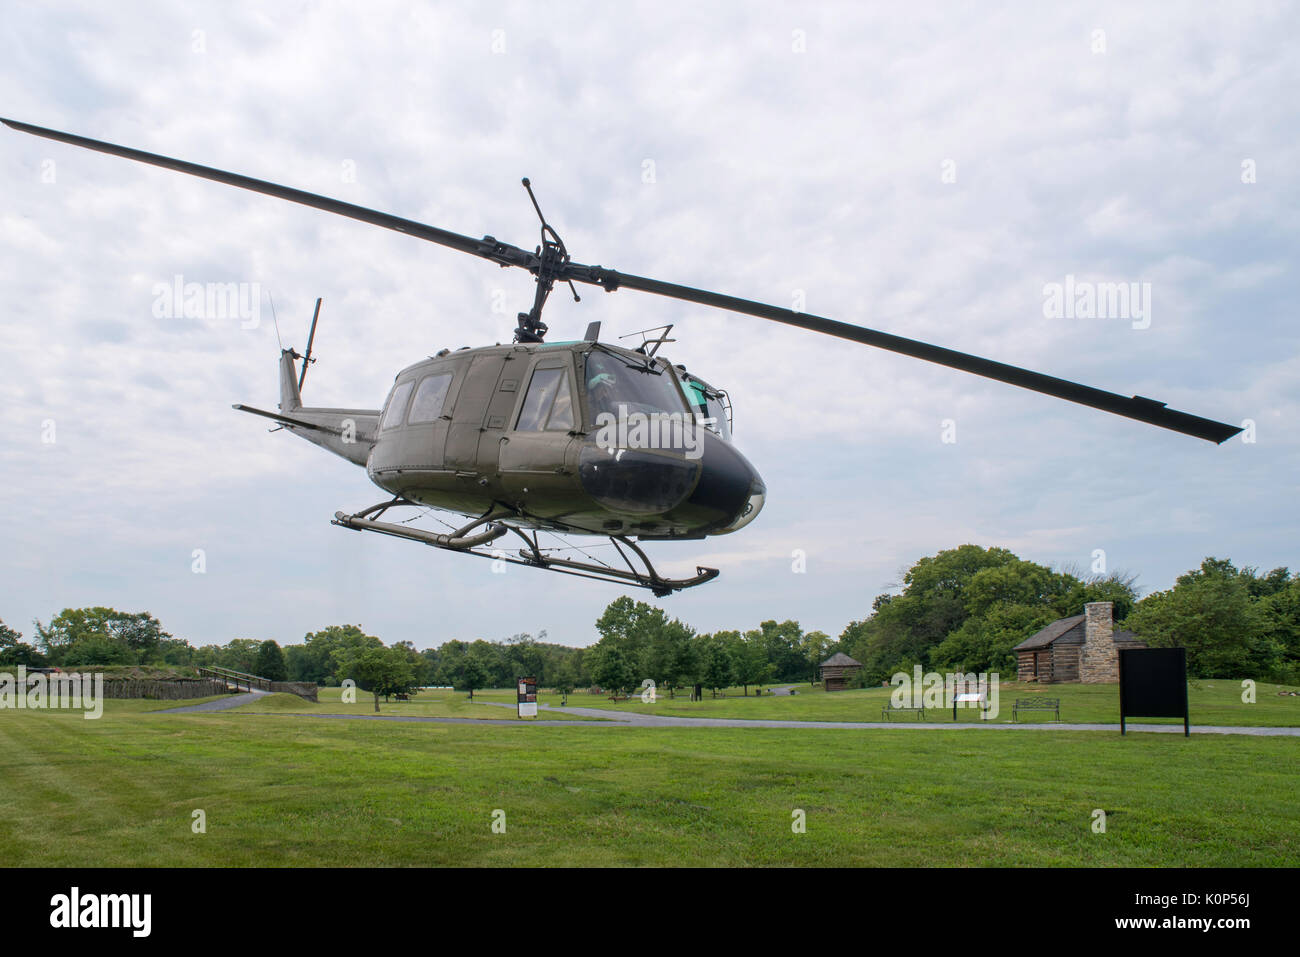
[281,341,766,540]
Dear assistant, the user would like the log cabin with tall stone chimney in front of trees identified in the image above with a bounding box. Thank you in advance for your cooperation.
[1013,602,1147,684]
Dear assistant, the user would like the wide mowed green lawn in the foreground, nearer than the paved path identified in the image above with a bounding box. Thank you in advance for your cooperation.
[0,701,1300,866]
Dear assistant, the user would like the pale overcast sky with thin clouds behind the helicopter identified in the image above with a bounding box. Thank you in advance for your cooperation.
[0,1,1300,648]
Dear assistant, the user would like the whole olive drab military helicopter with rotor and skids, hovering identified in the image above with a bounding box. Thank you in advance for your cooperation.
[3,120,1242,596]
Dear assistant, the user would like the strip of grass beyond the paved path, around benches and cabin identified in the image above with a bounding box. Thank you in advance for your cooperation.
[488,679,1300,728]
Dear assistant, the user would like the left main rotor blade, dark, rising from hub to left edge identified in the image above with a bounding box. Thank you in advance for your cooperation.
[0,117,537,269]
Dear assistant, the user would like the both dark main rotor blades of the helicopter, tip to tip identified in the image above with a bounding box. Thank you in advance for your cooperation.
[0,117,1242,443]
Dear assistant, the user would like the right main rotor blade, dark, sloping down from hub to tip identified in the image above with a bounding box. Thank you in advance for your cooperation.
[568,264,1242,443]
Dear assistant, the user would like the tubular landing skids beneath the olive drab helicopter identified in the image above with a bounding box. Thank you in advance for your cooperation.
[330,499,719,598]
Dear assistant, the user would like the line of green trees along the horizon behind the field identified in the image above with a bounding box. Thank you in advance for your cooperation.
[0,545,1300,696]
